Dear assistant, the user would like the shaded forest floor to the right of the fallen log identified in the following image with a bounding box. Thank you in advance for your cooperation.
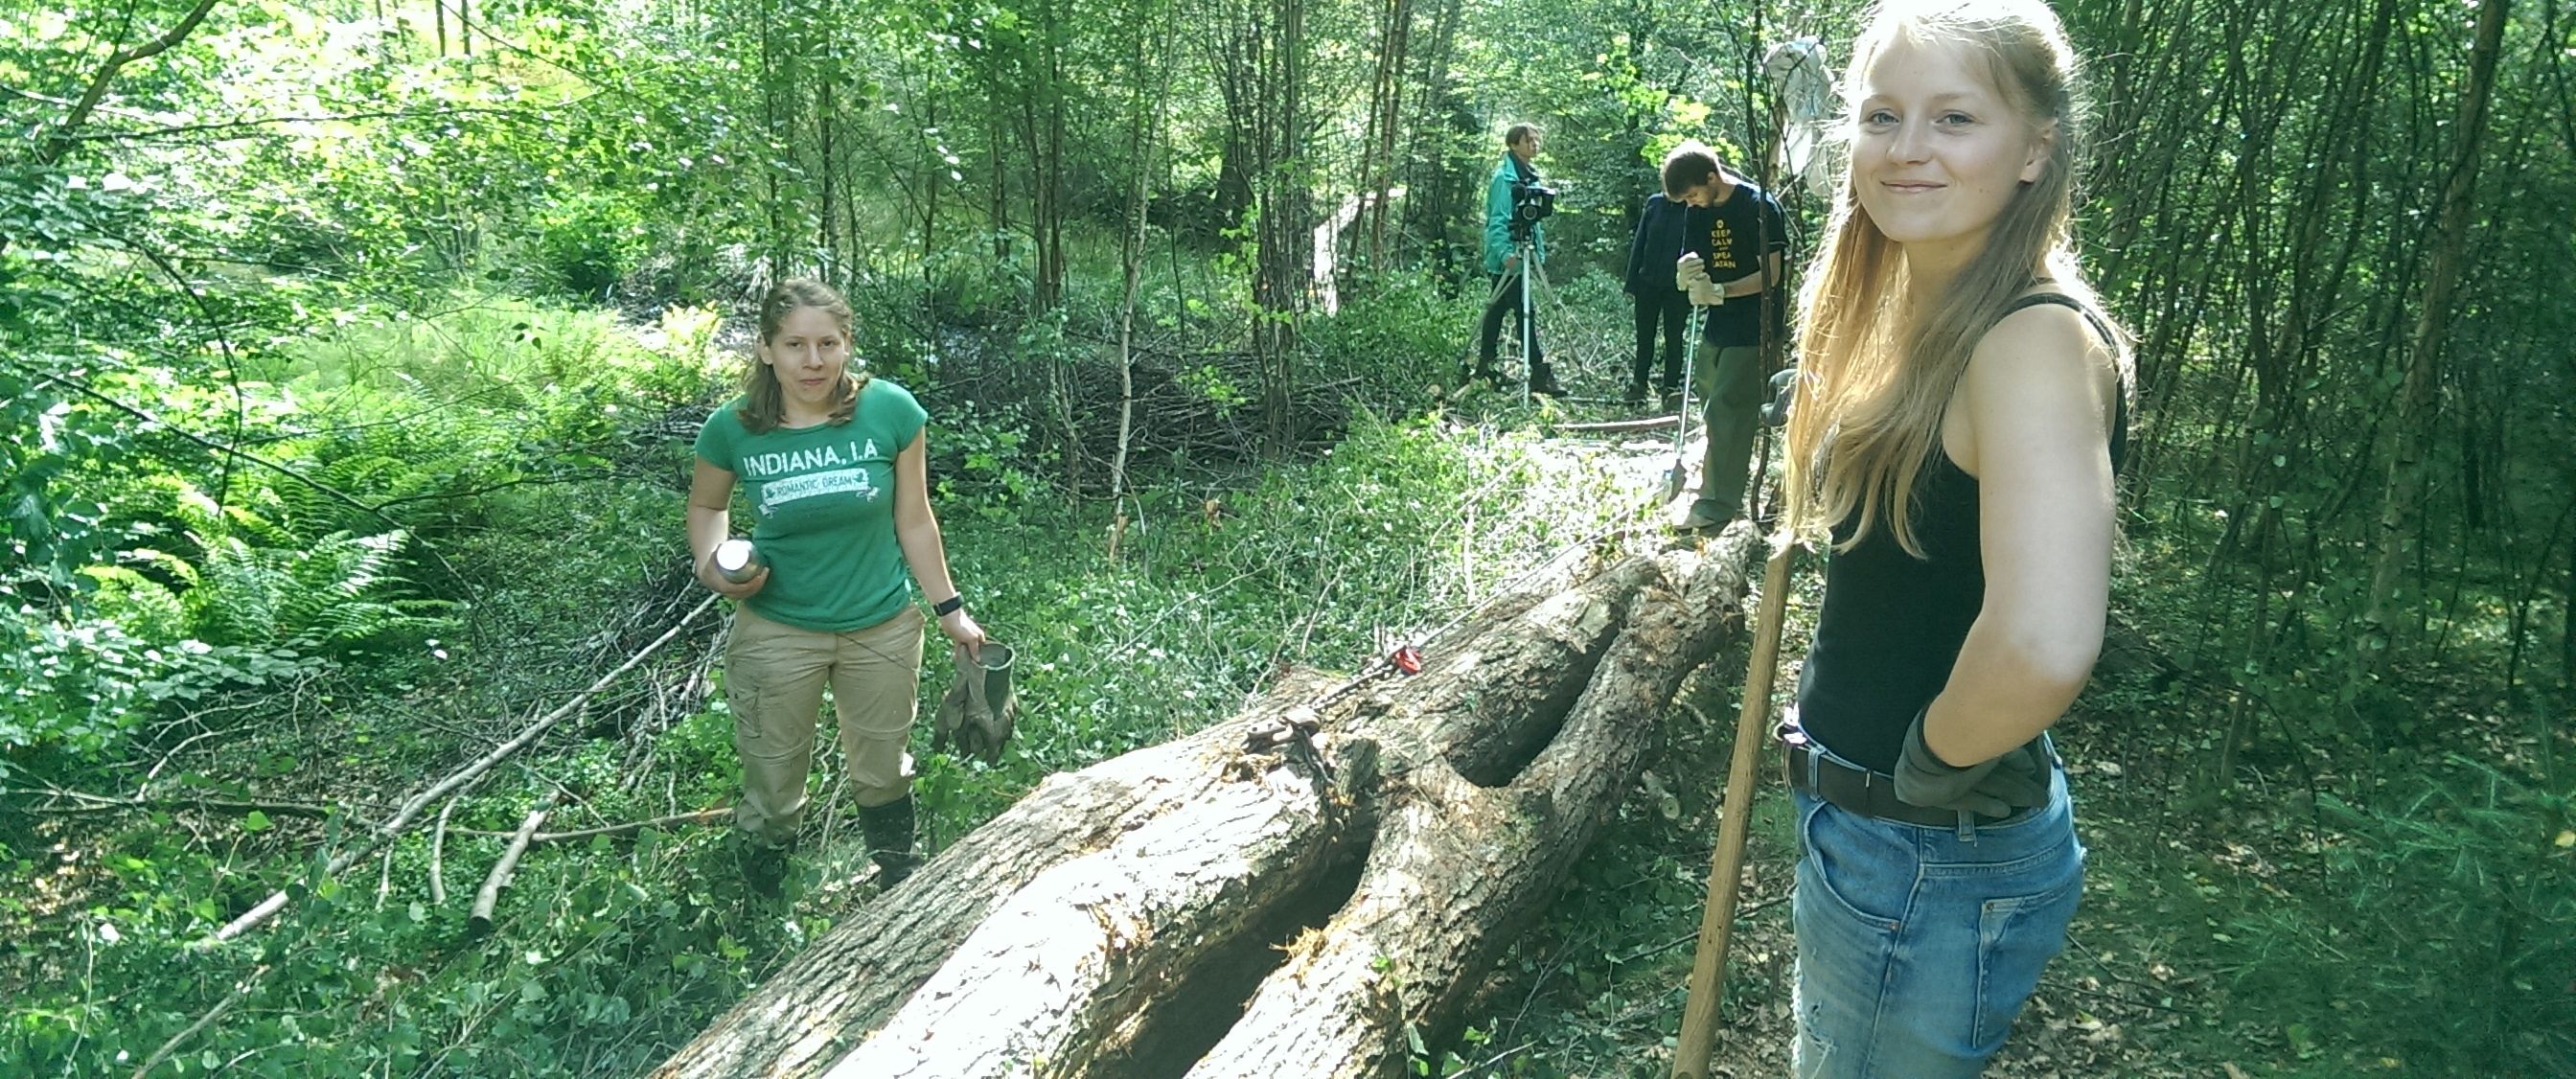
[1414,617,2576,1076]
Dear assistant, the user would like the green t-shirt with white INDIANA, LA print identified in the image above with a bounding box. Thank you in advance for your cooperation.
[698,379,930,633]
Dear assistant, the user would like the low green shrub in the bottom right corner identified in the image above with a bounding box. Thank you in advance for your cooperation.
[2220,754,2576,1074]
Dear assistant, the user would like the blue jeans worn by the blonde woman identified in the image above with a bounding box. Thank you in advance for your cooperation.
[1790,746,2084,1079]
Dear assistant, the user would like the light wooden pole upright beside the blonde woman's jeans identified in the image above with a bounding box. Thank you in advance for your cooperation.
[1672,543,1798,1079]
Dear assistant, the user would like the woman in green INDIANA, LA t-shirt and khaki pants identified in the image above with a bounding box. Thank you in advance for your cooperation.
[688,281,984,891]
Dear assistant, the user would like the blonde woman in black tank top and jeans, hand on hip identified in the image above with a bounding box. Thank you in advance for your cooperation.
[1782,0,2128,1076]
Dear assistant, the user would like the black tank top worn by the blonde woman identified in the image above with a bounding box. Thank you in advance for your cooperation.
[1798,293,2128,772]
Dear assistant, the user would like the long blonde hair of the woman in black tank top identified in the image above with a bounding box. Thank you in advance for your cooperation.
[1782,0,2130,559]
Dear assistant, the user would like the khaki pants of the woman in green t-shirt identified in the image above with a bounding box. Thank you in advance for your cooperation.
[724,606,922,842]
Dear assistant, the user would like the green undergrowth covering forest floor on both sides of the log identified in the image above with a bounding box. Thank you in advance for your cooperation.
[0,281,2576,1076]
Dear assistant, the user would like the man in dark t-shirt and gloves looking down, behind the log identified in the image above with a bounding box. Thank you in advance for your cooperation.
[1664,142,1787,528]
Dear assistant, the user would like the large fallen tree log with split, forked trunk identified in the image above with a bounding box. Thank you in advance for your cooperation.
[656,531,1749,1076]
